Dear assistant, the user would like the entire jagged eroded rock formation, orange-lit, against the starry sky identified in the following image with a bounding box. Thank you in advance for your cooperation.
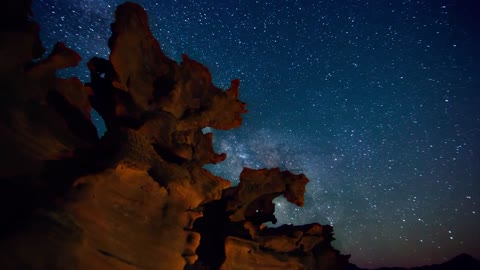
[0,0,347,269]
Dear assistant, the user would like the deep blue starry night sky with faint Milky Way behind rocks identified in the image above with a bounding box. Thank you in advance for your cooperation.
[33,0,480,267]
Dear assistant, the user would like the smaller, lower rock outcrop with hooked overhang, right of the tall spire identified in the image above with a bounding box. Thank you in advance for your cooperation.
[193,168,348,270]
